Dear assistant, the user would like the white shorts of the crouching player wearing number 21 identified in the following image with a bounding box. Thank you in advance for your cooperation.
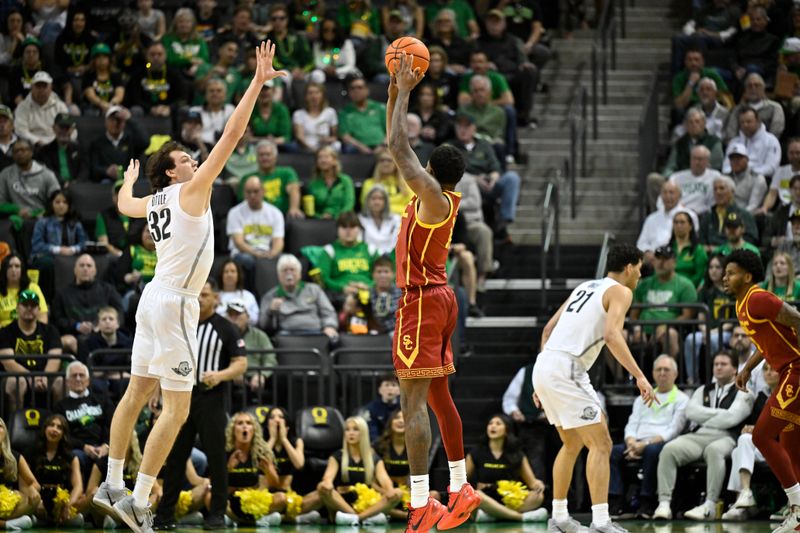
[533,351,603,429]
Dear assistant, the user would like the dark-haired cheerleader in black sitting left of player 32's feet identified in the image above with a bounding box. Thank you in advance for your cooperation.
[28,414,83,527]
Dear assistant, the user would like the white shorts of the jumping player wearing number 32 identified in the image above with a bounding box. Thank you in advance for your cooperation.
[131,282,200,391]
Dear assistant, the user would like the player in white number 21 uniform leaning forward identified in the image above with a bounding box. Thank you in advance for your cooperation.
[533,244,657,533]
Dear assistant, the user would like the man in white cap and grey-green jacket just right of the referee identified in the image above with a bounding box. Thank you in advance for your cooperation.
[225,300,278,393]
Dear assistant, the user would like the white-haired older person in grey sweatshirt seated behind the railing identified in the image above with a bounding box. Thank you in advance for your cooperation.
[258,254,339,340]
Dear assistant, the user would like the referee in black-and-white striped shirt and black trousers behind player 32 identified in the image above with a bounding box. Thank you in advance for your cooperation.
[153,279,247,530]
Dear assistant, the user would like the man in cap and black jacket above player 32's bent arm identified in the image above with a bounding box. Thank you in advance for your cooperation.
[89,106,147,183]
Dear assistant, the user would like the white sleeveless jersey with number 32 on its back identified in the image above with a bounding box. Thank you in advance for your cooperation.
[147,183,214,296]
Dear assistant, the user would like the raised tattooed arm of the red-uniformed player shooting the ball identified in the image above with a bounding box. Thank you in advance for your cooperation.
[387,53,450,224]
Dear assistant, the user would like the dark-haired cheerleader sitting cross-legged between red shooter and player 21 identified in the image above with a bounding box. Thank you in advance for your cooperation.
[467,415,547,522]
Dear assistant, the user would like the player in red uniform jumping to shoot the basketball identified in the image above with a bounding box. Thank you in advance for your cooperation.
[386,54,480,533]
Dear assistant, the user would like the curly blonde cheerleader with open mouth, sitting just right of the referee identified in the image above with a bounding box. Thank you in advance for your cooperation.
[225,412,286,527]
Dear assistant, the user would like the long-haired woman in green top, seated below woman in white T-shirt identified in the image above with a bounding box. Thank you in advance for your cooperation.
[306,146,356,218]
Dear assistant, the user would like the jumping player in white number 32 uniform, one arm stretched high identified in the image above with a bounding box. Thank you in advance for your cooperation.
[94,41,286,533]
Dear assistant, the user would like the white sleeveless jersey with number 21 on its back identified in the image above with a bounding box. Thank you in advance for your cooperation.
[544,278,619,370]
